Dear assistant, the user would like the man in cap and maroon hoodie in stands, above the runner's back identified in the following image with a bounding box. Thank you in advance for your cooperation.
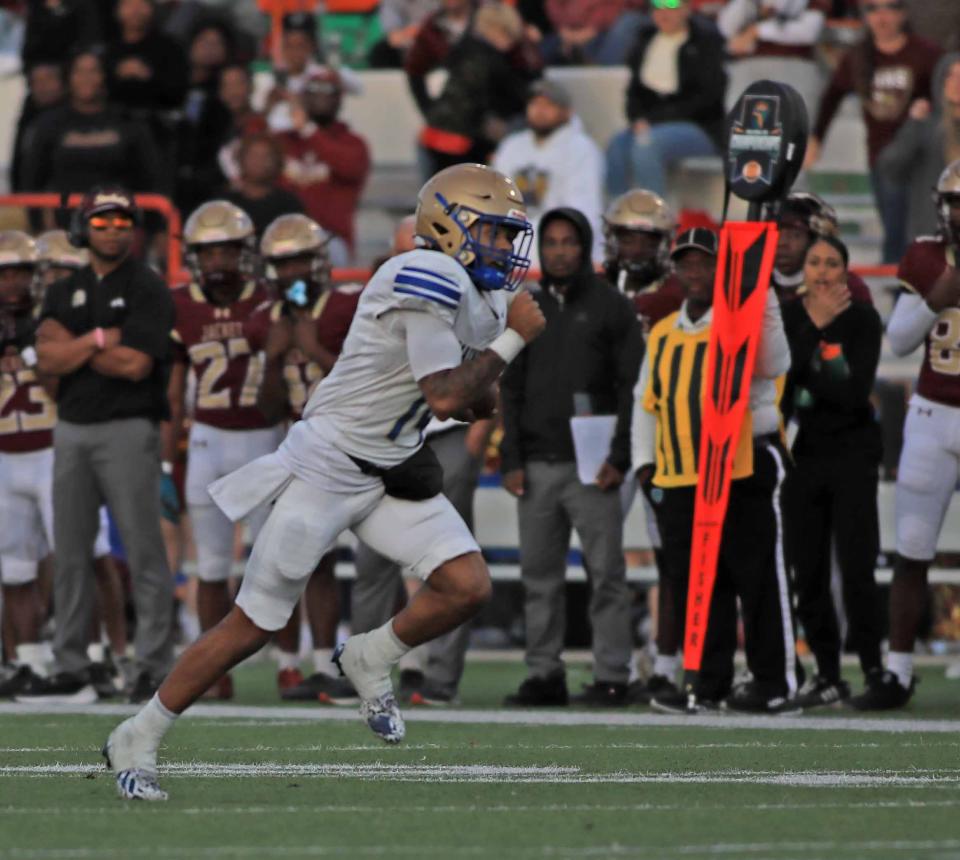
[280,66,370,266]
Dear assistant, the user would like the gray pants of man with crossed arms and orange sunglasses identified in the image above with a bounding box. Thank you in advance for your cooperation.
[53,418,173,680]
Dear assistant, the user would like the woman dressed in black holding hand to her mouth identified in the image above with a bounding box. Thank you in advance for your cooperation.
[782,236,883,708]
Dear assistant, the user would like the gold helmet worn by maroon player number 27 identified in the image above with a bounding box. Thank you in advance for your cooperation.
[183,200,256,298]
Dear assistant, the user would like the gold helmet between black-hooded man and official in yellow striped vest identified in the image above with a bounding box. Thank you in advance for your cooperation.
[603,188,677,284]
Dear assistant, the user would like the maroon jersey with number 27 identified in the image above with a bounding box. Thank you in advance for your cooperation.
[171,282,270,430]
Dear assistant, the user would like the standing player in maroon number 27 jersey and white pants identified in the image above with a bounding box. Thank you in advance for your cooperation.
[163,200,282,699]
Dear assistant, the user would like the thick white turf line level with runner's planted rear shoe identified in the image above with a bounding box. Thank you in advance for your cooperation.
[0,761,960,788]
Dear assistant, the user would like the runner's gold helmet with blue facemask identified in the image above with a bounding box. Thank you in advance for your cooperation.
[416,164,533,290]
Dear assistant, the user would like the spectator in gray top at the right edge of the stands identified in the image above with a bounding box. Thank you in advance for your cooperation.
[877,52,960,244]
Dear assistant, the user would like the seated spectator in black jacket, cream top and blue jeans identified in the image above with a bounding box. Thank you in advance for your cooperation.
[607,0,727,196]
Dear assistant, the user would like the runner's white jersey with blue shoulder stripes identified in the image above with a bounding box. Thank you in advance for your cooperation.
[285,245,508,466]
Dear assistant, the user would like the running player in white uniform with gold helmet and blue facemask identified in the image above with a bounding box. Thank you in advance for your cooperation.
[104,164,546,800]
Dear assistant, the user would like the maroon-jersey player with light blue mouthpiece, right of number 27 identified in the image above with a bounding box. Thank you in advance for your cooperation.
[250,214,360,705]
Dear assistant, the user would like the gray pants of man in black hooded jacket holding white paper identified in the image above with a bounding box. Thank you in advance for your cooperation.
[519,462,633,683]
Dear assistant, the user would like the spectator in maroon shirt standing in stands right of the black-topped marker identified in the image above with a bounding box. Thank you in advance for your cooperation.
[806,0,940,263]
